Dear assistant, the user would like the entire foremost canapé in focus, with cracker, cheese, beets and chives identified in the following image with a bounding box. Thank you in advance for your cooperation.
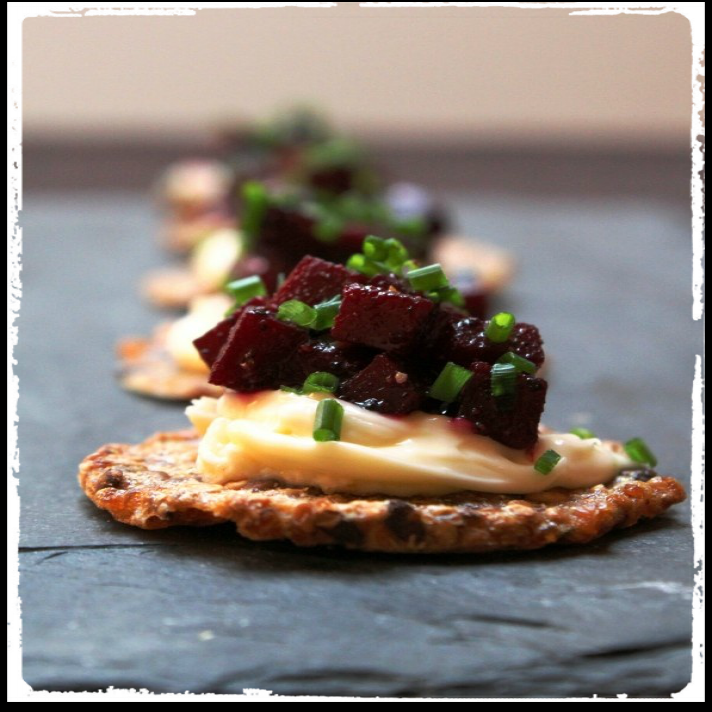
[79,236,685,552]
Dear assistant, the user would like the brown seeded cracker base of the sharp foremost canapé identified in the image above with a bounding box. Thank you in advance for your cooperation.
[79,431,685,553]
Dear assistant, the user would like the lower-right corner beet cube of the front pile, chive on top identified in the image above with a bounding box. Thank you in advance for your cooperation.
[458,361,547,449]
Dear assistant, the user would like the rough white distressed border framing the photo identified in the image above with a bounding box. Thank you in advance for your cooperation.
[7,2,705,702]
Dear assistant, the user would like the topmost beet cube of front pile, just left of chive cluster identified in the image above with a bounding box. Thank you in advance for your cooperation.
[274,255,365,306]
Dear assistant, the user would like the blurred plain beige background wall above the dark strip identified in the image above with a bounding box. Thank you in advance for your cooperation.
[23,3,692,150]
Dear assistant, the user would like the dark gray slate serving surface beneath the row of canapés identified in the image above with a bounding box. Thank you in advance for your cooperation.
[17,193,702,698]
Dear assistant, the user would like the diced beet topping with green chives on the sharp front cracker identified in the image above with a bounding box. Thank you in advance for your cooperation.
[194,237,547,449]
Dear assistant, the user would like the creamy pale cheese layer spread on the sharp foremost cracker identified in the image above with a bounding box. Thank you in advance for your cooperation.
[186,391,631,496]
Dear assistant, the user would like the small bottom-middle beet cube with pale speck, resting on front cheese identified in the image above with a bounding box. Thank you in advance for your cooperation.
[339,354,423,415]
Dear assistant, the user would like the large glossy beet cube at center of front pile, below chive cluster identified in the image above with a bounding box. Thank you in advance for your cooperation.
[331,284,433,352]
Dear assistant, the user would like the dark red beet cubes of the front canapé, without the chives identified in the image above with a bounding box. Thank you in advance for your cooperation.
[194,256,547,449]
